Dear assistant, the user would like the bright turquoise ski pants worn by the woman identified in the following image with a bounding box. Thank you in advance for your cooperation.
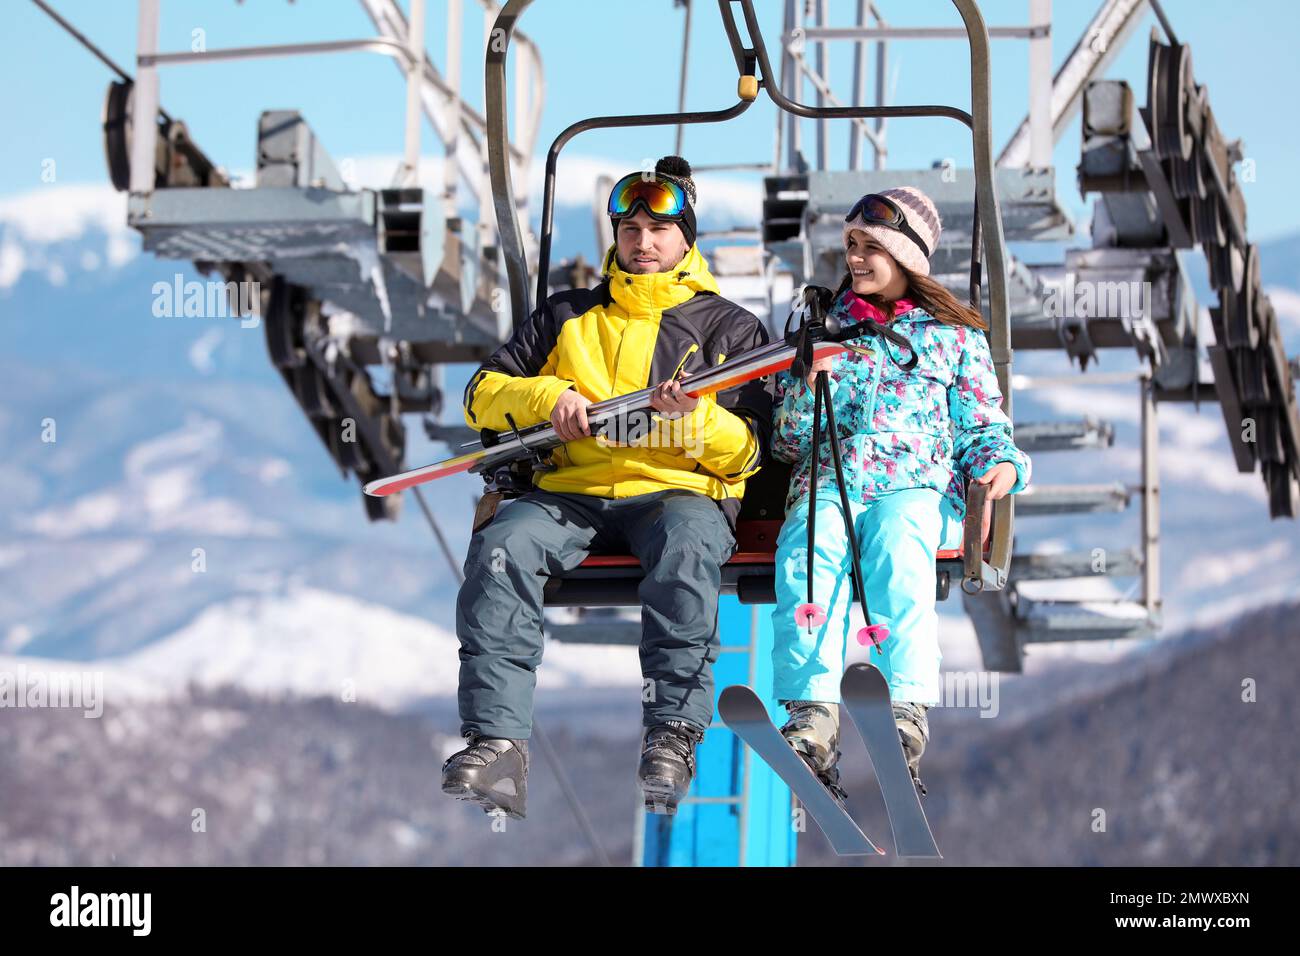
[772,488,962,704]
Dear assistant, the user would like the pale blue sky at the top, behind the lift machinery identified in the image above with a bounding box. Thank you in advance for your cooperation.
[0,0,1300,239]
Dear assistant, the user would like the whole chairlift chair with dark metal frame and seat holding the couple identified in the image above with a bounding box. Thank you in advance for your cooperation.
[485,0,1014,607]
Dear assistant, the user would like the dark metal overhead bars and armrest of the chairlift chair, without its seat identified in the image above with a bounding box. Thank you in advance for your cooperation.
[484,0,1015,593]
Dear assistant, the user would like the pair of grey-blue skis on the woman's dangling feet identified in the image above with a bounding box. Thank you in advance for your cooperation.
[718,663,943,860]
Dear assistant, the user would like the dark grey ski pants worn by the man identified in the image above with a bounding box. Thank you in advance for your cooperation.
[456,489,736,739]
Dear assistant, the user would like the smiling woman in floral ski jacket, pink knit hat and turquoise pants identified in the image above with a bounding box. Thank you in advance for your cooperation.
[772,187,1030,797]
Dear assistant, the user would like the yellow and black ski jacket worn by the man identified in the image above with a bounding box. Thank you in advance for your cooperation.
[464,246,772,527]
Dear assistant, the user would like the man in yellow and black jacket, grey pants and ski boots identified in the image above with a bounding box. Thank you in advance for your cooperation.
[442,156,772,817]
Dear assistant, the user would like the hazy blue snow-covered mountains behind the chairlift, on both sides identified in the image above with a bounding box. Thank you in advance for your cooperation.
[0,178,1300,706]
